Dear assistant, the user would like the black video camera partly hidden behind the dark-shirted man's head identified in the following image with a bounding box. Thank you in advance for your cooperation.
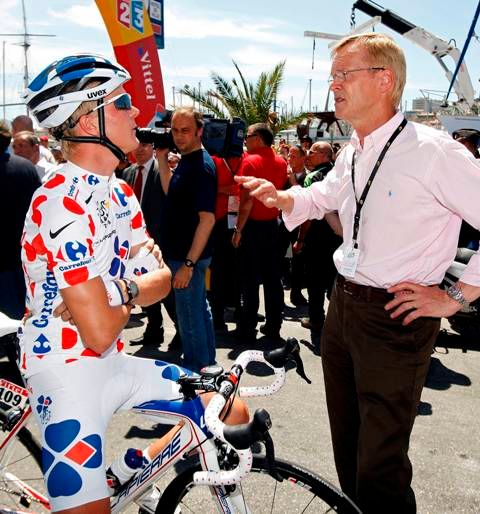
[137,111,246,157]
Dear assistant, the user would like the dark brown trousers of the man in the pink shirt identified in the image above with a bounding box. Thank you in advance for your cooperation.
[321,283,440,514]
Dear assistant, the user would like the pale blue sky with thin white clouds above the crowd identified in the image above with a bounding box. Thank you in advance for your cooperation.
[0,0,480,119]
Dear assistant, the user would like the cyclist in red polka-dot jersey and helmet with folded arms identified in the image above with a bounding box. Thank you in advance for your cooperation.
[19,54,248,514]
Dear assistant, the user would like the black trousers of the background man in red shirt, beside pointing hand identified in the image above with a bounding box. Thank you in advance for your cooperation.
[239,219,283,332]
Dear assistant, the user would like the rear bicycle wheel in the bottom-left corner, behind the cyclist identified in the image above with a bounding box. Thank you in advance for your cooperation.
[0,427,50,513]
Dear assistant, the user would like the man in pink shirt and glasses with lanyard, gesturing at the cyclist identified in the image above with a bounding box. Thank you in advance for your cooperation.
[239,34,480,514]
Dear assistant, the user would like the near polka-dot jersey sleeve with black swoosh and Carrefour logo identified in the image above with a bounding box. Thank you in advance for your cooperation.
[25,193,100,289]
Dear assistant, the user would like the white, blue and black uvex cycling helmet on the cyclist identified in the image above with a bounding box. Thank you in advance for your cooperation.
[23,54,130,128]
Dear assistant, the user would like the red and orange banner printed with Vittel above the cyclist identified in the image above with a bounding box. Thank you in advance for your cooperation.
[95,0,165,127]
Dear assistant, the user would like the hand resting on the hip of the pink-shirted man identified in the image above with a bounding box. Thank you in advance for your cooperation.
[385,282,462,325]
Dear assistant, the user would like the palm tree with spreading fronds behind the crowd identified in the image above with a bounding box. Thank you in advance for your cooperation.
[182,61,305,132]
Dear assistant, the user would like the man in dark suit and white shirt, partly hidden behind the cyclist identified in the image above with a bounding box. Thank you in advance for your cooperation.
[123,143,180,346]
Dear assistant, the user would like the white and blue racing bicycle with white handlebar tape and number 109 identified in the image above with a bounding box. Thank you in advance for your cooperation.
[0,310,360,514]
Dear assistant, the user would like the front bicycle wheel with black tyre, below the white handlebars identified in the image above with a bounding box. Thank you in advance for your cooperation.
[156,456,360,514]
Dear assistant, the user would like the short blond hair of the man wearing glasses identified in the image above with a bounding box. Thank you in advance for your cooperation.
[332,32,407,107]
